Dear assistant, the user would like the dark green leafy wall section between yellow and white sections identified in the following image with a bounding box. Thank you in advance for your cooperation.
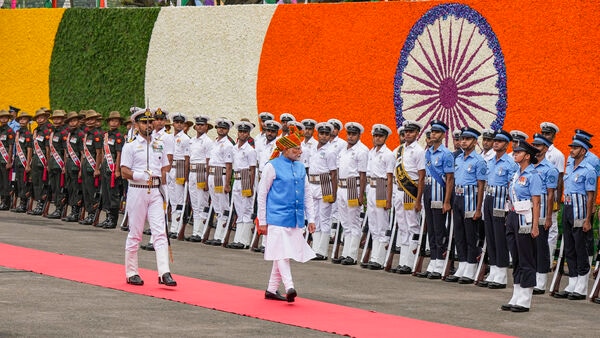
[50,8,160,116]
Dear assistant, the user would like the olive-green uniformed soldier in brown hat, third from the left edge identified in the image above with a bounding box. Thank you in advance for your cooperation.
[27,108,54,216]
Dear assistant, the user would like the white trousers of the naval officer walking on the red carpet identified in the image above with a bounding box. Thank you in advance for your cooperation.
[125,186,169,277]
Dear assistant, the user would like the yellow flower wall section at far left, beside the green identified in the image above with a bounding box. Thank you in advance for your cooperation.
[0,9,65,114]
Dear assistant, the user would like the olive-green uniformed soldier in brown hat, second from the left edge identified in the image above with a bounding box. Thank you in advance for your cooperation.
[11,111,33,213]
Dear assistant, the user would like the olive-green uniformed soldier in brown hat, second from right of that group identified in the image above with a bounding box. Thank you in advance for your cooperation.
[79,110,104,225]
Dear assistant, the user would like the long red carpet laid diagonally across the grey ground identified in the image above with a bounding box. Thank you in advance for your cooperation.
[0,243,510,337]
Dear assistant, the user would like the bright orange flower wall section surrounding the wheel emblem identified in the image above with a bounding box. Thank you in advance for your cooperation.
[257,0,600,151]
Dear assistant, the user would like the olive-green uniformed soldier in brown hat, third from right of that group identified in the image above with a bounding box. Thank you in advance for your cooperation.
[62,111,85,222]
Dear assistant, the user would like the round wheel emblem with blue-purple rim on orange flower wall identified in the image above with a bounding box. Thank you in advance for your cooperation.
[394,4,506,143]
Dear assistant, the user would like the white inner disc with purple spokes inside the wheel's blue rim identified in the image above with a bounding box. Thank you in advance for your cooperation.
[401,16,499,129]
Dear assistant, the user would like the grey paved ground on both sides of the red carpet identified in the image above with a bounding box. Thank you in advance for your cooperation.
[0,211,600,337]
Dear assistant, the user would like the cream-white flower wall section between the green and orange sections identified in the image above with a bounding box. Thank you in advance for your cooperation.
[145,5,276,128]
